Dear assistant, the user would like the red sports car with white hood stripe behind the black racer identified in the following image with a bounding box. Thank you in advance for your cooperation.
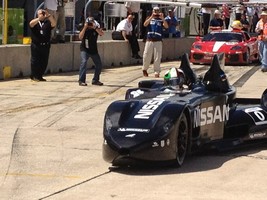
[190,30,259,65]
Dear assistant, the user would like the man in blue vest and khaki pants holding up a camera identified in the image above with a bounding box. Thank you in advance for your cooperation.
[142,7,168,78]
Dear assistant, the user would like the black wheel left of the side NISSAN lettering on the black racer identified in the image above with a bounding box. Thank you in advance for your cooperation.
[176,114,189,166]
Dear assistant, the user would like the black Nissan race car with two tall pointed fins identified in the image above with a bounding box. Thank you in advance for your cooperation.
[103,54,267,166]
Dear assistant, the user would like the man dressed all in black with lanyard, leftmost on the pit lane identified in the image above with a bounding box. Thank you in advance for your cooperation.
[29,10,56,81]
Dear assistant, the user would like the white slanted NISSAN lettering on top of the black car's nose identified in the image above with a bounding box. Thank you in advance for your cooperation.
[134,94,175,119]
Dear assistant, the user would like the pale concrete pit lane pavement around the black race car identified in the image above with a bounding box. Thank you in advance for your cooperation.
[0,62,267,200]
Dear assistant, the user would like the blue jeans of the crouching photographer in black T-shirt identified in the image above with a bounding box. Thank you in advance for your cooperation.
[79,51,102,83]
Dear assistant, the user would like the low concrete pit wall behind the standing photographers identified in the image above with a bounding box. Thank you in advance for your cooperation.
[0,38,194,80]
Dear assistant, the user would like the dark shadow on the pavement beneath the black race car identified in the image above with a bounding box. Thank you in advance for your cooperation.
[110,140,267,176]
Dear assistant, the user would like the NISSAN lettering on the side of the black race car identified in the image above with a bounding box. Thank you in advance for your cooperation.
[194,104,229,128]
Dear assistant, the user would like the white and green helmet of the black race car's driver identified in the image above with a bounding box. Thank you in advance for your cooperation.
[164,67,185,88]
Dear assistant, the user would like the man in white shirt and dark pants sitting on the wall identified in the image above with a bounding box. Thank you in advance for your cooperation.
[116,15,141,59]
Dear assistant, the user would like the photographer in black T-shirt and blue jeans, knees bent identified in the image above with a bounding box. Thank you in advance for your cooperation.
[79,17,104,86]
